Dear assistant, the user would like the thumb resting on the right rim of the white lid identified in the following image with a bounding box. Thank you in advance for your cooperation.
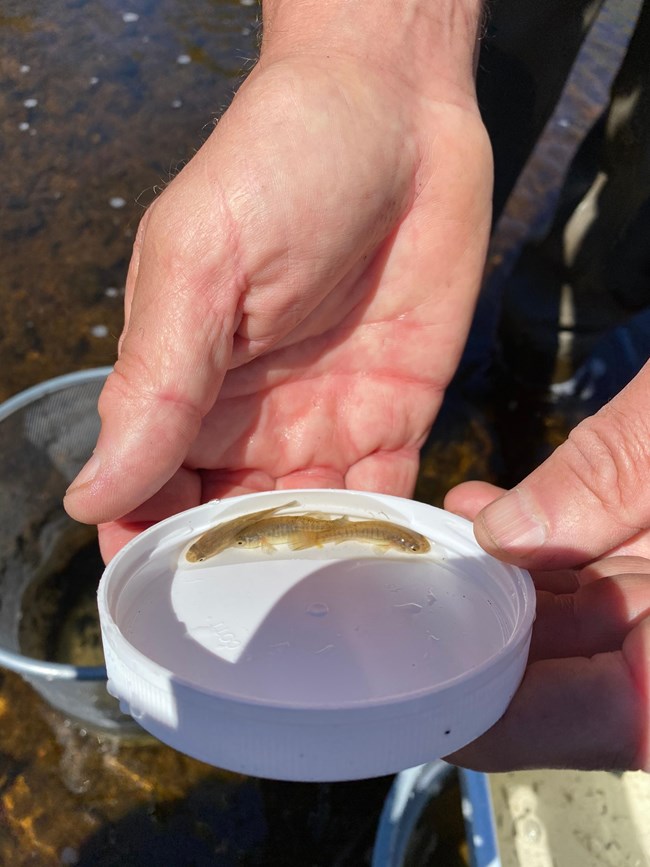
[474,363,650,569]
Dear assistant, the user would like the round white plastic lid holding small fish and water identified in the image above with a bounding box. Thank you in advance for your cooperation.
[98,490,535,781]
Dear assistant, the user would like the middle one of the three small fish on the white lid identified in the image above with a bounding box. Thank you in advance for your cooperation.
[232,512,349,552]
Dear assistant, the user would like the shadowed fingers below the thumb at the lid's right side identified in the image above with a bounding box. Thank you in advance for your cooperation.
[449,557,650,772]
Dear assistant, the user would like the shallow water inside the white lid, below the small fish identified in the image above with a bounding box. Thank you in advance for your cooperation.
[117,557,507,707]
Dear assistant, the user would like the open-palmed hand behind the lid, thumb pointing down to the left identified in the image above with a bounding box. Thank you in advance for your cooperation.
[66,0,491,559]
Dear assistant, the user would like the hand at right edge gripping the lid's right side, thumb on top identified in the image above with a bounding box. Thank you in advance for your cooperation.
[445,365,650,771]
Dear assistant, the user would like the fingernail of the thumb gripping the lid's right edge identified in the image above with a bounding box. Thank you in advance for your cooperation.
[480,488,546,554]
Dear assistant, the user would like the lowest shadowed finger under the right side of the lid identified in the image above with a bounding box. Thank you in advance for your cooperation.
[447,636,650,773]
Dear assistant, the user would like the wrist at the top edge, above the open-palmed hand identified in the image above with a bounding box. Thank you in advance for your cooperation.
[261,0,483,102]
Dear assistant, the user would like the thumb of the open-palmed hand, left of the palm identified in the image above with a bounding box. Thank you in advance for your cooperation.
[65,156,239,524]
